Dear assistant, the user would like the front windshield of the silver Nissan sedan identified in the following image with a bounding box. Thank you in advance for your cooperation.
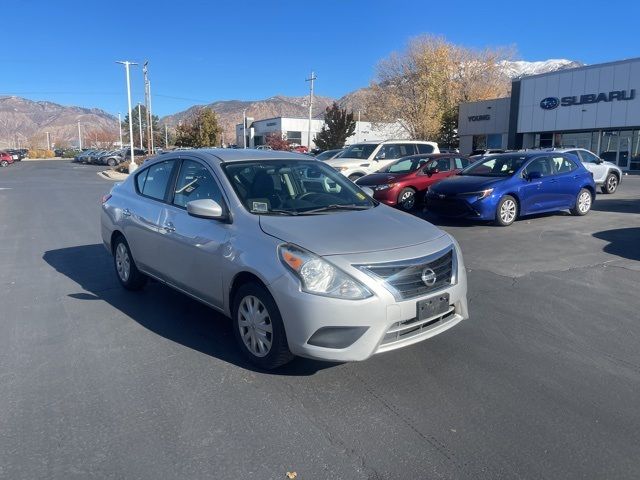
[223,160,377,215]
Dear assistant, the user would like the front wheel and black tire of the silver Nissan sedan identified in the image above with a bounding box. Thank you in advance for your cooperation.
[231,282,293,370]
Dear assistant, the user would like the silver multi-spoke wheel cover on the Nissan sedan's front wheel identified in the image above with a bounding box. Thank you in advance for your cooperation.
[238,295,273,357]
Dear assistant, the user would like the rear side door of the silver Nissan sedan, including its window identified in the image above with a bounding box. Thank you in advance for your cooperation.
[121,158,176,276]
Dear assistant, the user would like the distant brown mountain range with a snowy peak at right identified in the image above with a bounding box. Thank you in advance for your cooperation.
[0,59,583,148]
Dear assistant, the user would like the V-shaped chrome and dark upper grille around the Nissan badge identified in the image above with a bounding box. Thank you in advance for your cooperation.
[356,247,456,300]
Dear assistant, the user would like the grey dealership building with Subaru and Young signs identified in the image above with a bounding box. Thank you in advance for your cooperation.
[458,58,640,171]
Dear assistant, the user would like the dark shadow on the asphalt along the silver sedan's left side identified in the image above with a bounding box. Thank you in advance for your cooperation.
[43,244,336,376]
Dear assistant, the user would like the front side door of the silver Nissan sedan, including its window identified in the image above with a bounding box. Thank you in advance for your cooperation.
[158,156,230,308]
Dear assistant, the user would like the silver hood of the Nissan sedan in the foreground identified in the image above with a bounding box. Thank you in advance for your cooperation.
[260,205,444,255]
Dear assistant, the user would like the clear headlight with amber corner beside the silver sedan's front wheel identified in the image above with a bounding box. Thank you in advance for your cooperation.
[278,244,373,300]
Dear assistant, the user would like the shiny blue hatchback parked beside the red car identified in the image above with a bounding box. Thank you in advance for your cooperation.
[426,151,596,226]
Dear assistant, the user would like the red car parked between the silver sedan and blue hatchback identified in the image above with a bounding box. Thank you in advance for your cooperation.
[356,153,470,210]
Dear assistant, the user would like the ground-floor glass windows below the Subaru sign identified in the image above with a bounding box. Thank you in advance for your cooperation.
[535,129,640,171]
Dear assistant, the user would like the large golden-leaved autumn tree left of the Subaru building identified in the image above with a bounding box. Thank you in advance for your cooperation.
[366,35,511,140]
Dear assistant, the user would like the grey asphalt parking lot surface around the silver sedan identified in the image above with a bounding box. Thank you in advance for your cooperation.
[0,161,640,479]
